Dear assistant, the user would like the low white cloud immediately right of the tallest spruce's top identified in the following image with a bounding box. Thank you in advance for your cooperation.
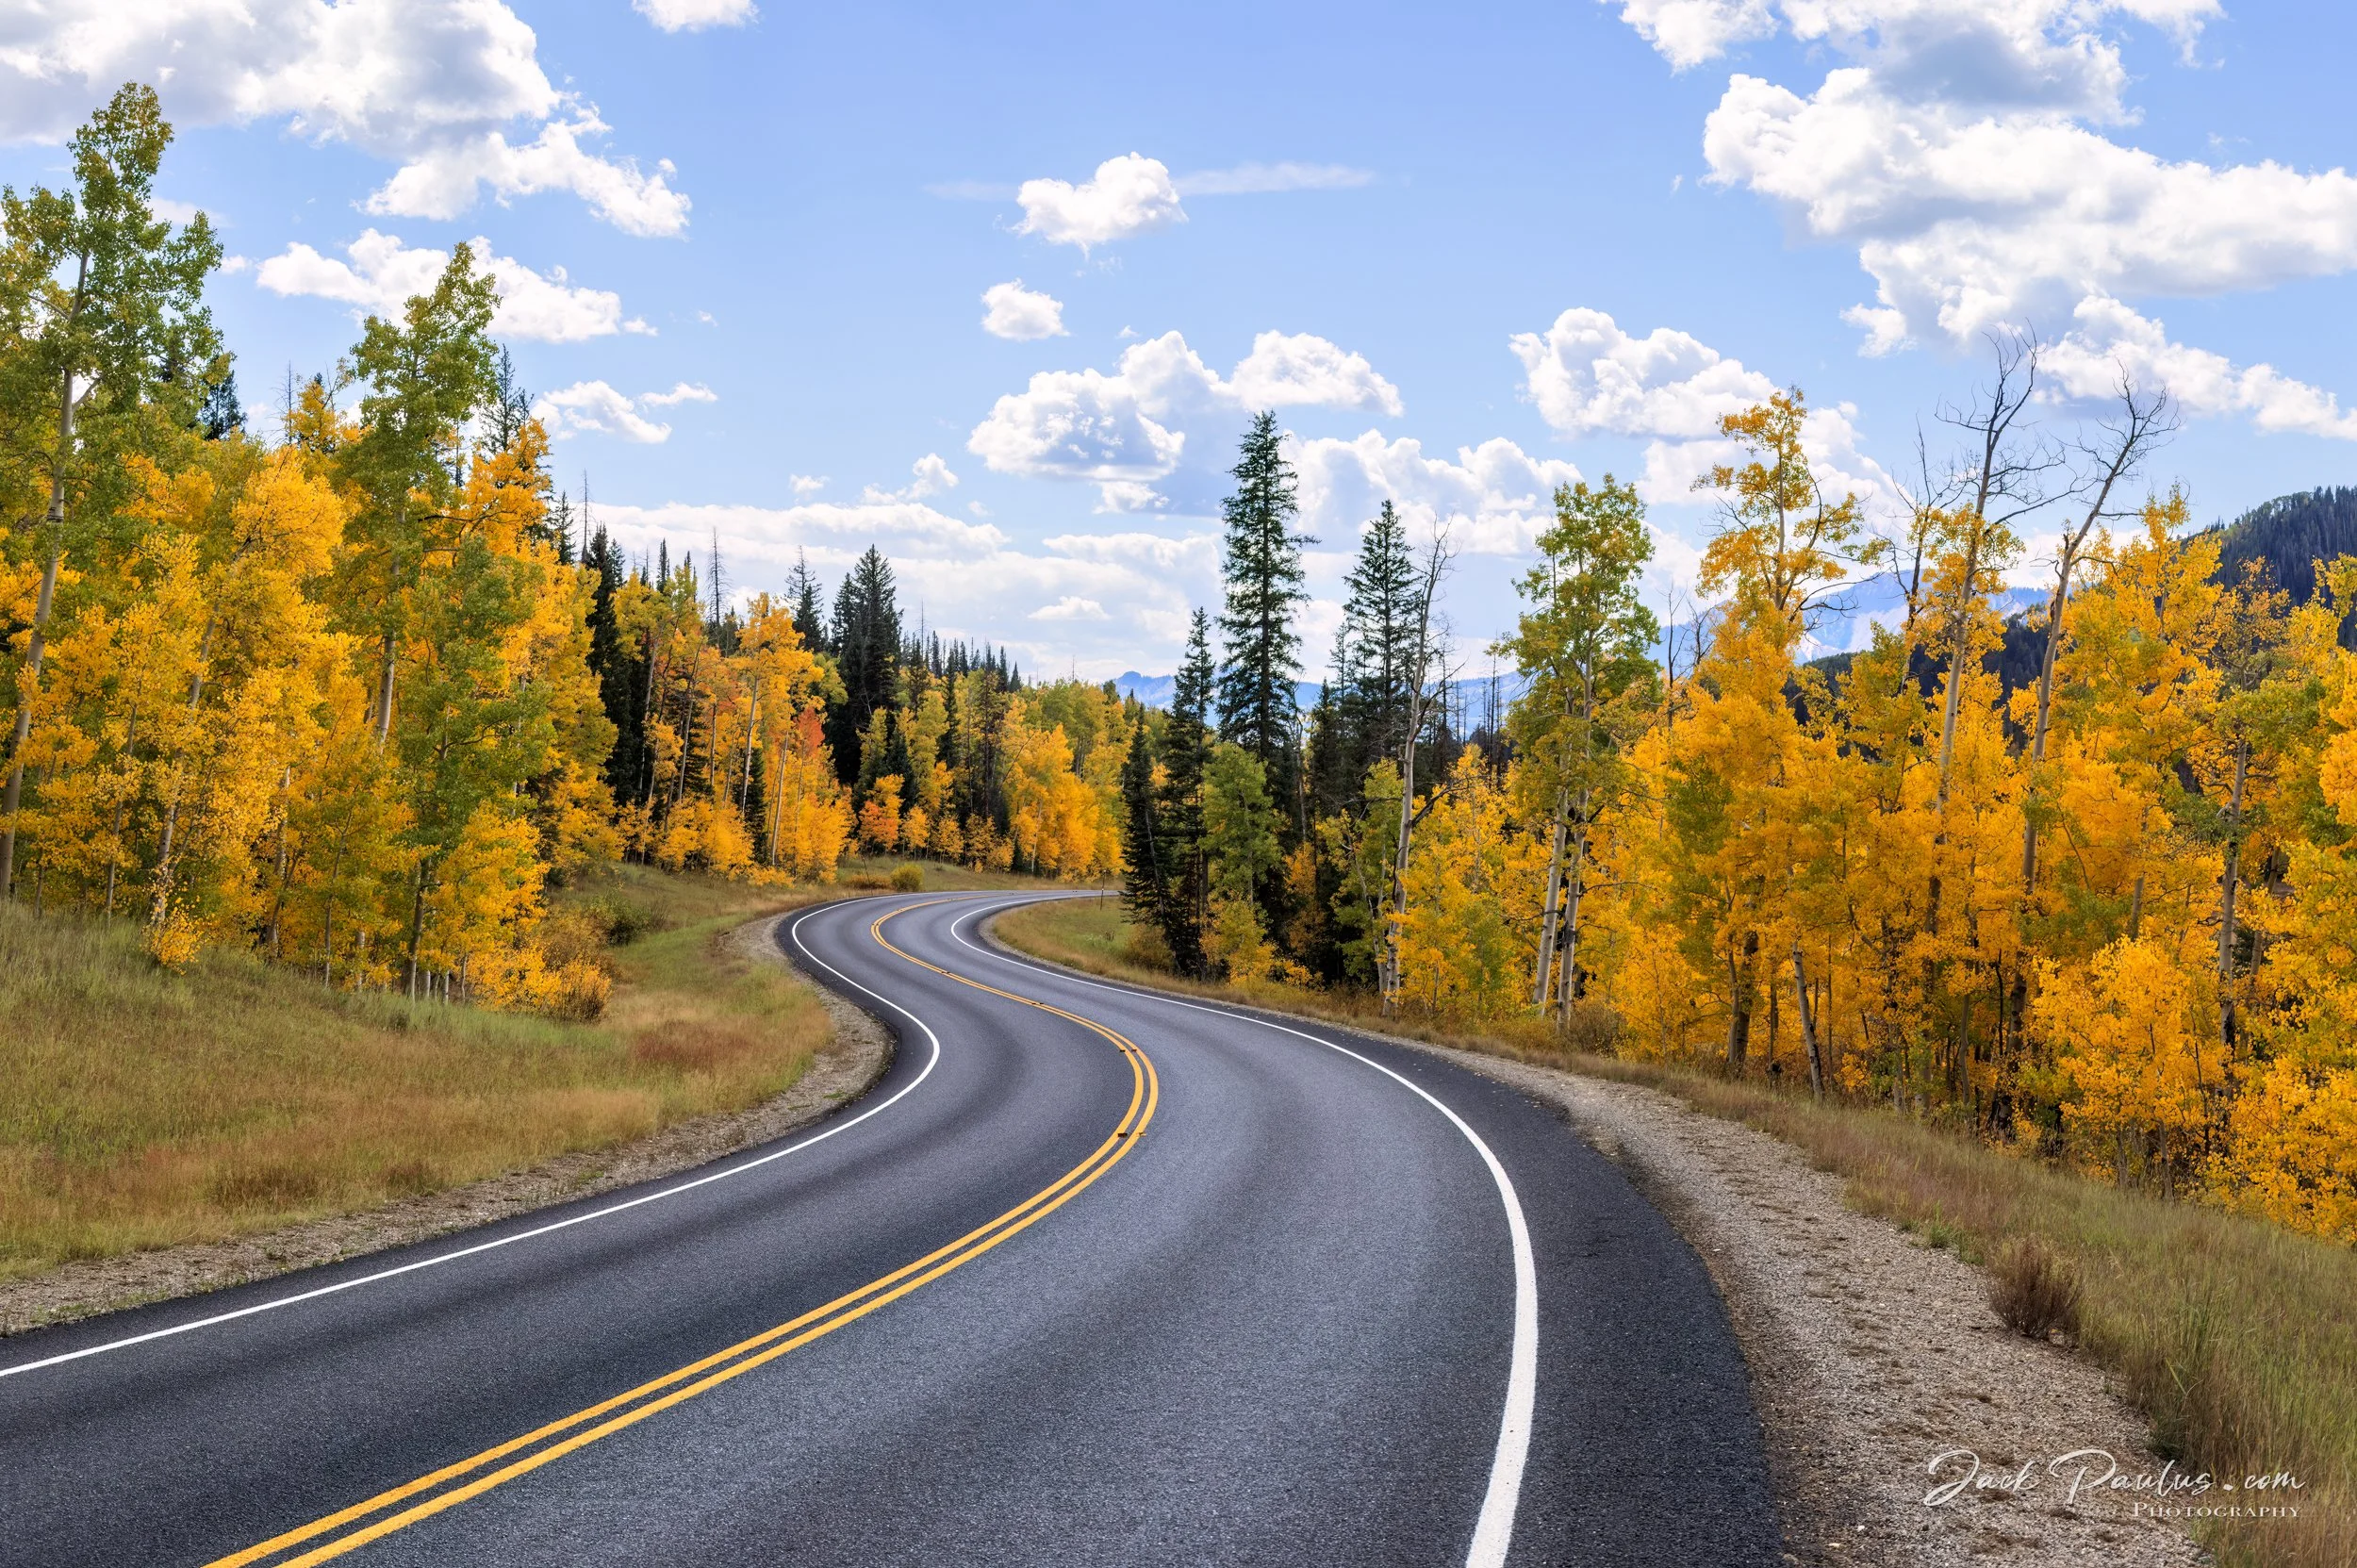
[1287,429,1579,554]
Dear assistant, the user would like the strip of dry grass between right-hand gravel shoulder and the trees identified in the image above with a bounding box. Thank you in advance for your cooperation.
[997,900,2357,1568]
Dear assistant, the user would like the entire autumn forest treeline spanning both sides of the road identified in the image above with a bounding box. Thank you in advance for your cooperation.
[13,88,2357,1240]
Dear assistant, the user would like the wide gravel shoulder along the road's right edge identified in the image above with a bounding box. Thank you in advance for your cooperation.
[1400,1040,2211,1568]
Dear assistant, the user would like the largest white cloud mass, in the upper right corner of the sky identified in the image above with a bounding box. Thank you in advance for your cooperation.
[1593,0,2357,434]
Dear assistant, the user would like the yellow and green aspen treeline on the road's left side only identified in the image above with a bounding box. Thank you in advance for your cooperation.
[0,88,1129,1014]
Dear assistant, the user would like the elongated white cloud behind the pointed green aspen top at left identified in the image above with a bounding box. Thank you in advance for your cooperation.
[255,229,655,342]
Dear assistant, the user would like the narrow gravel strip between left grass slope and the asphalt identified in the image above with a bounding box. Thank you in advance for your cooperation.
[0,915,891,1334]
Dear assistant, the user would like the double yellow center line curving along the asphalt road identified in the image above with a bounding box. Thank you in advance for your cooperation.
[206,899,1160,1568]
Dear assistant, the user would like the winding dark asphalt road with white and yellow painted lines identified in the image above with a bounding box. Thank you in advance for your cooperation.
[0,894,1777,1568]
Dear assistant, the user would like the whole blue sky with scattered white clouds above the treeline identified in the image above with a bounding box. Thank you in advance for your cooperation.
[0,0,2357,677]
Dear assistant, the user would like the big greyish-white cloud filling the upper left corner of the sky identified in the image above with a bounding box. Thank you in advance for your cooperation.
[0,0,688,234]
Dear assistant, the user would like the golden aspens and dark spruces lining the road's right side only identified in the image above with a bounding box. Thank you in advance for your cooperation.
[1122,370,2357,1240]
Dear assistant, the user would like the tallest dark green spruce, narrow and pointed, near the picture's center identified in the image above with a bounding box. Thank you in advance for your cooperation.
[1219,413,1318,801]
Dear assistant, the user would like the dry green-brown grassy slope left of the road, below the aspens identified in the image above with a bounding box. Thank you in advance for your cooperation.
[0,861,1028,1278]
